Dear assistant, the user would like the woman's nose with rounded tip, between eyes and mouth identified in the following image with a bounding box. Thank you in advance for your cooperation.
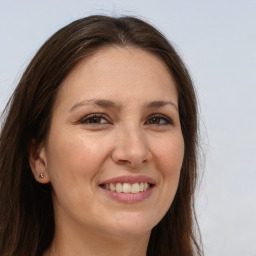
[112,128,152,168]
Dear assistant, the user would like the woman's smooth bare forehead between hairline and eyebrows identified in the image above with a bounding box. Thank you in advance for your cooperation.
[56,47,178,110]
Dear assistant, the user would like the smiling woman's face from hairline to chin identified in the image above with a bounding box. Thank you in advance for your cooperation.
[33,47,184,241]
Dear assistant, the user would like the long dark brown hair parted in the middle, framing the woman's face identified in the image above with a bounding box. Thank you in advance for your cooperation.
[0,16,203,256]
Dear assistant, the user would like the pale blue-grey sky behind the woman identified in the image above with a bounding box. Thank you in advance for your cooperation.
[0,0,256,256]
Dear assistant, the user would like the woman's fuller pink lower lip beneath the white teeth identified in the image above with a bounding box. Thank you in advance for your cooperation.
[102,186,154,204]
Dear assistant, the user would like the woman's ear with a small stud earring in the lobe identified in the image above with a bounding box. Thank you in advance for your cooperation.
[29,139,50,184]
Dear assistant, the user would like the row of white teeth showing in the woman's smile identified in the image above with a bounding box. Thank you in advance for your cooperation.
[103,182,149,194]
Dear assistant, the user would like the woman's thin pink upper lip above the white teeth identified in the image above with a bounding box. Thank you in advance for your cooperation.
[100,175,156,185]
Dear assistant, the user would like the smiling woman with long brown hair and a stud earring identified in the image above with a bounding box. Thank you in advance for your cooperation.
[0,16,202,256]
